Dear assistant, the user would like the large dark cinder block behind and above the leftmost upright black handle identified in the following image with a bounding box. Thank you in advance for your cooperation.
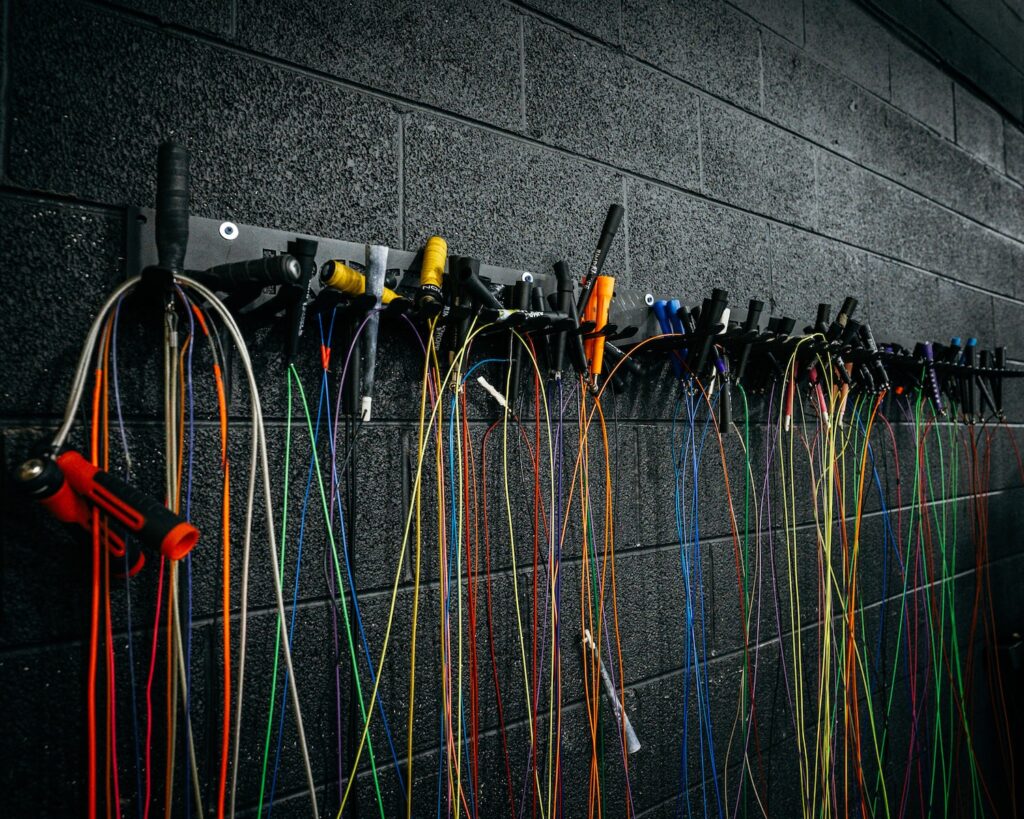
[7,3,398,243]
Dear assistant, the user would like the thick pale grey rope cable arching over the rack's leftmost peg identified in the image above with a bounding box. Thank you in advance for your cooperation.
[50,274,318,817]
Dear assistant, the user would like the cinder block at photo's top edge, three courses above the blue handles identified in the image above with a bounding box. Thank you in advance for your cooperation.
[623,0,760,110]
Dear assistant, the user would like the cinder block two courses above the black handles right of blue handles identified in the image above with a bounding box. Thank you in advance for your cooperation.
[700,100,815,225]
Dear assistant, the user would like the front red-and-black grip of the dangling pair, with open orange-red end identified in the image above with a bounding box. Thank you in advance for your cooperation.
[57,450,199,560]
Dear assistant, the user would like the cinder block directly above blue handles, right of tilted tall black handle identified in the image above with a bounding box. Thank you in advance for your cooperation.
[627,181,771,306]
